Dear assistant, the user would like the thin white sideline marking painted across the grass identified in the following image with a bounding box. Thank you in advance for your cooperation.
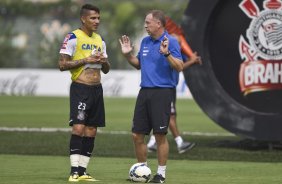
[0,127,235,137]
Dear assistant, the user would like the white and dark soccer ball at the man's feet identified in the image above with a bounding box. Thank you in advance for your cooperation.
[129,163,152,183]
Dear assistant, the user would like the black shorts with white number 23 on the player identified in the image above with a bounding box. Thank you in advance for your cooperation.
[69,82,105,127]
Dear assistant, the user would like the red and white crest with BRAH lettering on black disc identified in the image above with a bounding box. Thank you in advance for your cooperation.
[239,0,282,95]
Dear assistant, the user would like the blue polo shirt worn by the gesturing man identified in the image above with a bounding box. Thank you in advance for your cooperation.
[137,31,182,88]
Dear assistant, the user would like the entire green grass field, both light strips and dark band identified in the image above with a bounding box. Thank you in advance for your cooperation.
[0,96,282,184]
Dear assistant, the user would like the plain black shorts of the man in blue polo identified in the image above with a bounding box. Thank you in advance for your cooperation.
[132,88,173,135]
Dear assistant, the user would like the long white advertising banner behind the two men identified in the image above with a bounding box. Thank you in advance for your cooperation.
[0,69,192,98]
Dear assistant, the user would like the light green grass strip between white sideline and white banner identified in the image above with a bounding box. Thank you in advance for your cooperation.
[0,96,226,132]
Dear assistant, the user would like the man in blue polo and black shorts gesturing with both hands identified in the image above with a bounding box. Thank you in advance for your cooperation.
[119,10,183,183]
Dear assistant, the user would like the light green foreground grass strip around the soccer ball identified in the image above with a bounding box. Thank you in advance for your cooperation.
[0,155,282,184]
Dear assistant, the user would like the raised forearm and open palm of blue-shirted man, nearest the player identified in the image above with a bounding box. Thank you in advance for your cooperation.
[119,35,141,70]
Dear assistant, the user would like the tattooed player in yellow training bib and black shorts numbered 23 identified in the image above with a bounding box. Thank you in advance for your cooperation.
[59,4,110,182]
